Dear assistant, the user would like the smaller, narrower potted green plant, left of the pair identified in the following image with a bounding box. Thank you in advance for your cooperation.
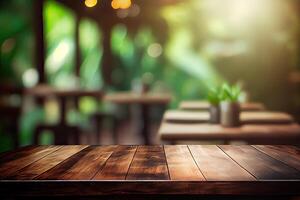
[207,88,221,124]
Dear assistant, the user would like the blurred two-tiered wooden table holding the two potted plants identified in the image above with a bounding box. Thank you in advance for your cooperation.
[159,110,300,144]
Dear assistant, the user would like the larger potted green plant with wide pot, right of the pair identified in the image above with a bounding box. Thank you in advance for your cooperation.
[220,84,241,127]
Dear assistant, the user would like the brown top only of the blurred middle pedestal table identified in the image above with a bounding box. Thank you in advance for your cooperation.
[104,92,172,104]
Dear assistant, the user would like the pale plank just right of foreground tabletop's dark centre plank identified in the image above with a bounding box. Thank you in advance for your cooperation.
[164,145,205,181]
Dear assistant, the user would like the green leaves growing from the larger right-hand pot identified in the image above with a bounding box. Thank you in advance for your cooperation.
[221,83,241,102]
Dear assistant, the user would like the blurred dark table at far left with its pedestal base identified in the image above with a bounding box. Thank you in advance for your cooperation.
[25,85,103,144]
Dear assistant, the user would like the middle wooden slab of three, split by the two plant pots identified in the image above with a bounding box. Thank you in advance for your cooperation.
[163,110,295,124]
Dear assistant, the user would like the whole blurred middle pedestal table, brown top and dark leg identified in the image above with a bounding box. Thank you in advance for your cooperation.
[104,92,172,144]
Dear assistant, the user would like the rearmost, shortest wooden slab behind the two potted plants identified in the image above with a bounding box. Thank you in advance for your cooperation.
[179,101,265,111]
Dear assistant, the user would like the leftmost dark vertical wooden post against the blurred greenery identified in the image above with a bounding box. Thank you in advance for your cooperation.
[33,0,46,83]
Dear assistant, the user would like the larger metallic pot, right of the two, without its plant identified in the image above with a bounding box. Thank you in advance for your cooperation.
[220,101,240,127]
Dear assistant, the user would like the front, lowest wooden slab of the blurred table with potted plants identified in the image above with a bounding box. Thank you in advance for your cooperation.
[158,122,300,144]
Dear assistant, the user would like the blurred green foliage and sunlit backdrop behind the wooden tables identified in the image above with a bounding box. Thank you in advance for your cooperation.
[0,0,300,151]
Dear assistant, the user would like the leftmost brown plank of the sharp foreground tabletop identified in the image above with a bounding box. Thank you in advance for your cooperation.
[0,146,62,179]
